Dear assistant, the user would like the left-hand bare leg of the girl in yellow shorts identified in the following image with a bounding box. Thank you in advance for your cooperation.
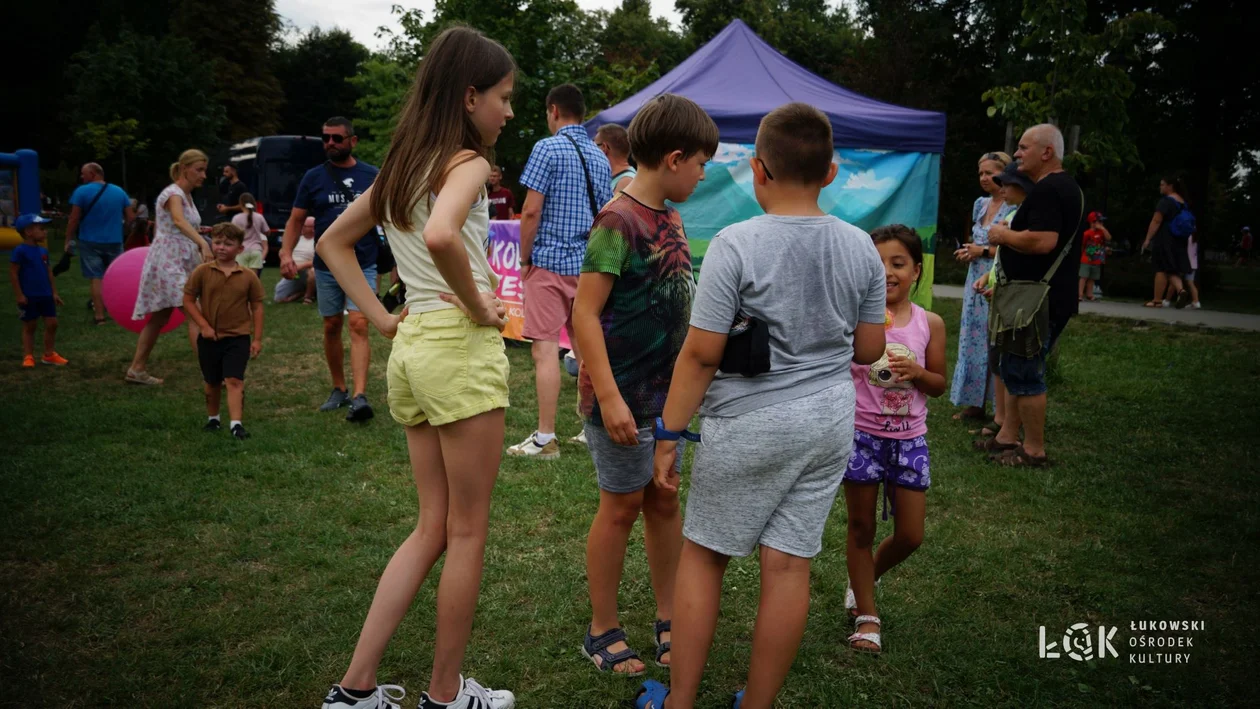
[341,423,449,689]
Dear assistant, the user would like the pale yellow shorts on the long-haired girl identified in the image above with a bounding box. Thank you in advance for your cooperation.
[387,309,508,426]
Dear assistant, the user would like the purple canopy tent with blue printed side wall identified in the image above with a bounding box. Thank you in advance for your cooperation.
[586,20,945,307]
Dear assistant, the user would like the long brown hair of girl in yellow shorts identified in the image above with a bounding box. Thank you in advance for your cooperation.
[370,26,517,229]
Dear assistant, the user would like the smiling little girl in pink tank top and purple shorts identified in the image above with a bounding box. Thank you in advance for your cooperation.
[844,224,945,654]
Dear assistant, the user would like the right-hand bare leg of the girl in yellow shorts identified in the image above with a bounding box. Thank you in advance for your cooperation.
[428,409,504,701]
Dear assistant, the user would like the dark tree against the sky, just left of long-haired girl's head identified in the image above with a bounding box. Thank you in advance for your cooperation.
[271,26,370,135]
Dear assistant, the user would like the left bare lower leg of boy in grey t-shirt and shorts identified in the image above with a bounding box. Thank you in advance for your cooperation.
[658,539,731,709]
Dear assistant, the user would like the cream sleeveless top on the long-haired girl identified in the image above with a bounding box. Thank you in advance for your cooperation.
[384,189,499,314]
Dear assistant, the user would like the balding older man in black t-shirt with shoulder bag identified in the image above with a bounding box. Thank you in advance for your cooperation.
[989,125,1085,466]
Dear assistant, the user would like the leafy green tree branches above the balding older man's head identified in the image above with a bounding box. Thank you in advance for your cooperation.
[982,0,1172,173]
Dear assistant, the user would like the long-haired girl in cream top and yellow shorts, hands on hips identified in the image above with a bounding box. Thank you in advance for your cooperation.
[306,28,515,709]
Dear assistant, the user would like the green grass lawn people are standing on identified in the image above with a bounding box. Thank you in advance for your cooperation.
[0,243,1260,708]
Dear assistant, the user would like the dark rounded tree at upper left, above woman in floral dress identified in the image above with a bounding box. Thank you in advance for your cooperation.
[64,28,224,196]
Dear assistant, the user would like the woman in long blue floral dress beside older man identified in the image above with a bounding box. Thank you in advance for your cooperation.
[949,152,1011,419]
